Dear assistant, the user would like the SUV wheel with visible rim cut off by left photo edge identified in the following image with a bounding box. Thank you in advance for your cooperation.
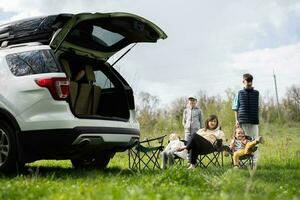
[0,121,17,172]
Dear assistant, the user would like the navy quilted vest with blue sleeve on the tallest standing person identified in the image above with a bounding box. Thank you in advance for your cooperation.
[232,88,259,124]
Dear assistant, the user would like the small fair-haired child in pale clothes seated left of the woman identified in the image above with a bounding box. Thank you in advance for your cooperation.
[161,133,187,169]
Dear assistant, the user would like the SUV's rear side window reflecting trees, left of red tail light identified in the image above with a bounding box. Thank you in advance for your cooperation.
[6,50,62,76]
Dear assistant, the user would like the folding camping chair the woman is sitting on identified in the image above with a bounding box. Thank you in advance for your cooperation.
[196,139,224,168]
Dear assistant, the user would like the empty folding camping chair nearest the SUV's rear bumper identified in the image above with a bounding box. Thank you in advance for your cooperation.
[128,135,166,170]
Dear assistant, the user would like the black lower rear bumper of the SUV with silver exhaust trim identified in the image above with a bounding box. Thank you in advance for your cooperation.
[18,127,140,162]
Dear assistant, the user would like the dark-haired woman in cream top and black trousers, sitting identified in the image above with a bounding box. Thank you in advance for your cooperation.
[179,115,225,169]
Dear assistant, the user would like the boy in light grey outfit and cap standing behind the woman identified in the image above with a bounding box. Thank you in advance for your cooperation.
[182,95,203,141]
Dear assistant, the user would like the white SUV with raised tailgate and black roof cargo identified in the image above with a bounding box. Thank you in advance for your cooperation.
[0,13,167,171]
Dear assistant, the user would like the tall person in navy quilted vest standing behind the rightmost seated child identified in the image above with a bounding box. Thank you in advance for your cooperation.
[232,74,259,167]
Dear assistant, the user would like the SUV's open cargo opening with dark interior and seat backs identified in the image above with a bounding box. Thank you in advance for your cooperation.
[58,53,134,121]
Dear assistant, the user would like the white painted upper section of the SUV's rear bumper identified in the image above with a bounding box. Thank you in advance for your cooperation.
[13,99,139,132]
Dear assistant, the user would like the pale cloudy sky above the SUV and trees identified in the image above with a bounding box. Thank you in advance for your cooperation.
[0,0,300,105]
